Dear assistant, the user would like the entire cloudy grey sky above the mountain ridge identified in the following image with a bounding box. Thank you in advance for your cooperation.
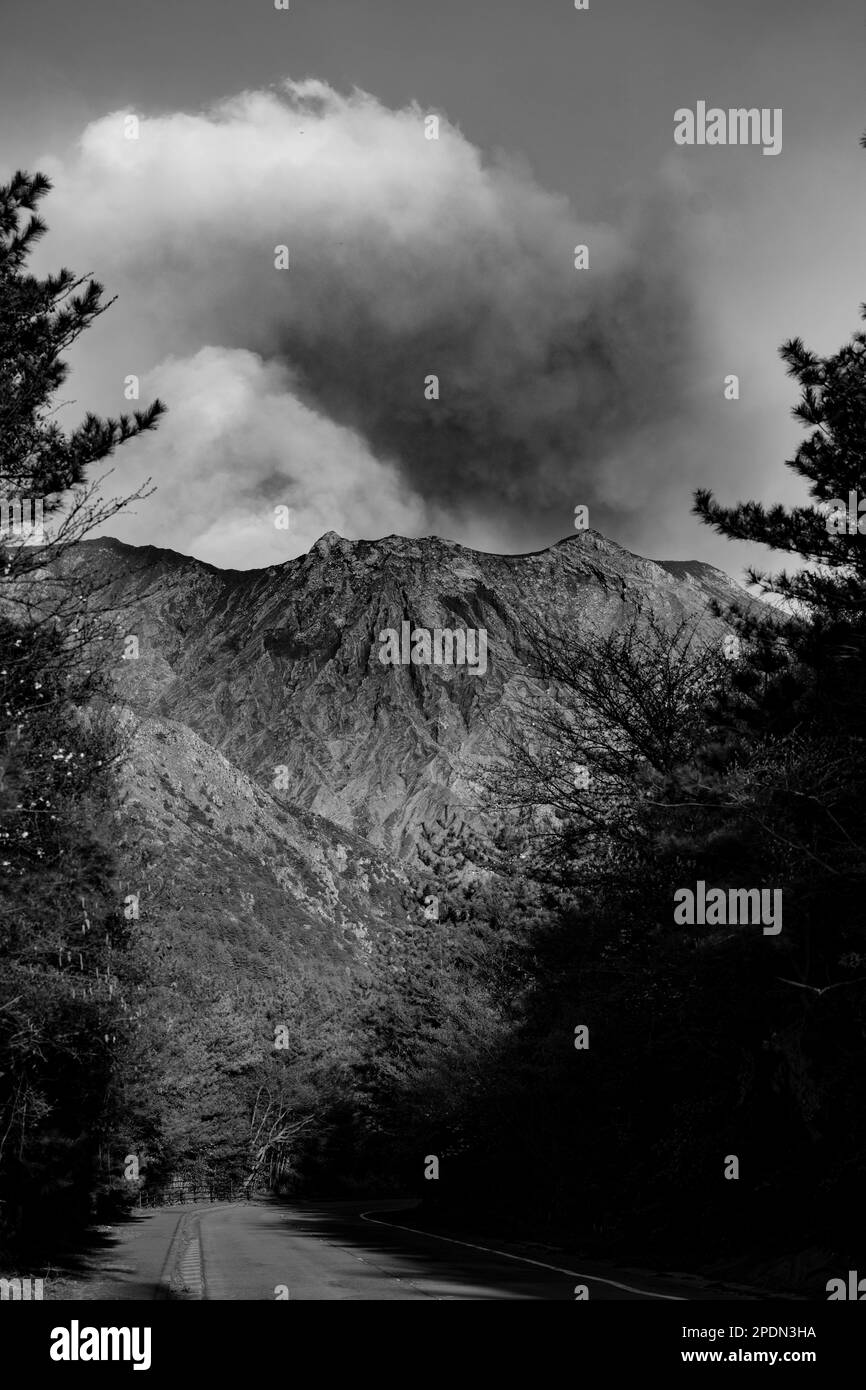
[0,0,866,574]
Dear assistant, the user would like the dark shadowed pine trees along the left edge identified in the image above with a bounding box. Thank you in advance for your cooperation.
[0,174,163,1250]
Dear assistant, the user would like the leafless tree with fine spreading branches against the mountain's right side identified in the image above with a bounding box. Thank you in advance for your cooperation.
[484,603,730,876]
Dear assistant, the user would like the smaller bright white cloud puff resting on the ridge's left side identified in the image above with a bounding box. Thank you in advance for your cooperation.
[96,348,424,569]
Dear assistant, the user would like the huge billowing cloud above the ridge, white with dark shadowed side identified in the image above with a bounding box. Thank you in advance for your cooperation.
[37,81,706,566]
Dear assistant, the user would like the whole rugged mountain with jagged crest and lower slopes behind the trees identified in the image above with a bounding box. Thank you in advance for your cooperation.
[52,531,748,1168]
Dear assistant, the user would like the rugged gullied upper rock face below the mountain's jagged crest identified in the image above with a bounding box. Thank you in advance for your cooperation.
[76,531,748,858]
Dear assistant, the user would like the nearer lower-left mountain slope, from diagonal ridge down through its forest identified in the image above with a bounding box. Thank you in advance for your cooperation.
[112,710,418,1177]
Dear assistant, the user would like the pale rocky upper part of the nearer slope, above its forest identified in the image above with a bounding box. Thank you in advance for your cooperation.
[118,709,406,973]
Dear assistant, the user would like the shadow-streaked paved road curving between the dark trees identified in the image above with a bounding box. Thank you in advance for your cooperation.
[61,1201,717,1301]
